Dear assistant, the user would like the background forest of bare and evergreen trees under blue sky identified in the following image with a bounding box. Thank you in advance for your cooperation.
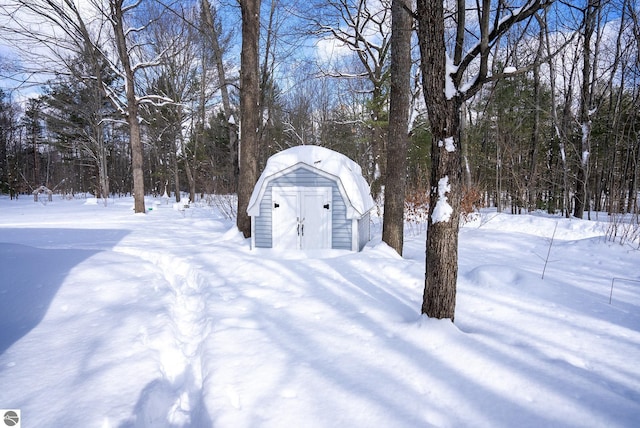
[0,0,640,222]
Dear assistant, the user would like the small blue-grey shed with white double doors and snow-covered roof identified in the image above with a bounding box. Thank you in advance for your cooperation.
[247,146,374,251]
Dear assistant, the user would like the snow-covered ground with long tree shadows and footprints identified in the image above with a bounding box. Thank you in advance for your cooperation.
[0,196,640,428]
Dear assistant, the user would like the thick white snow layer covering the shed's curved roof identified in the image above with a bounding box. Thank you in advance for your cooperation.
[247,146,374,217]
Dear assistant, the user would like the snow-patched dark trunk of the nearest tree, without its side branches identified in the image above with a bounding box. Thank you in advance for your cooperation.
[417,0,462,321]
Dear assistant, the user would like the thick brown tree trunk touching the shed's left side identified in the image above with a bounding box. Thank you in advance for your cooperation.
[236,0,260,238]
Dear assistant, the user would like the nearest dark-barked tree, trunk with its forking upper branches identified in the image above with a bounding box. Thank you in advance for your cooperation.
[416,0,553,321]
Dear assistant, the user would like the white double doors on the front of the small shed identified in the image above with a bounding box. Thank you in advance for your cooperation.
[271,187,332,250]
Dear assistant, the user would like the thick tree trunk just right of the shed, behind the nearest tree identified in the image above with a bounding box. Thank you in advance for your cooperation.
[382,0,413,255]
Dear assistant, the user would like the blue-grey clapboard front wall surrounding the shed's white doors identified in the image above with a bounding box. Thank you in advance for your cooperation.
[254,168,350,250]
